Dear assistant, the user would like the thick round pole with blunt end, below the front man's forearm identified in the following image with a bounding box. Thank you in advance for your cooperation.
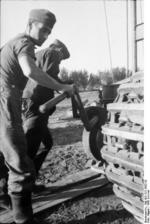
[39,93,67,114]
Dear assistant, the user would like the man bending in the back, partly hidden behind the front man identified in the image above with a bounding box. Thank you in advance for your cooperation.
[23,40,70,177]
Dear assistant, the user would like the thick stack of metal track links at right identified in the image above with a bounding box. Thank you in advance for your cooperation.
[101,74,144,223]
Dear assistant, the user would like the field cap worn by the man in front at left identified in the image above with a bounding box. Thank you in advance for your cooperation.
[29,9,56,29]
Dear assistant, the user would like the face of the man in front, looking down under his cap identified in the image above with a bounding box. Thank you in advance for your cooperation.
[30,22,51,46]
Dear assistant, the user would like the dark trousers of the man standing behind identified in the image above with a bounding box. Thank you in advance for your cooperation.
[23,99,53,174]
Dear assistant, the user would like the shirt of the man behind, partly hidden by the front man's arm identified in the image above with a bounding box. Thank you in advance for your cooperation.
[23,47,60,105]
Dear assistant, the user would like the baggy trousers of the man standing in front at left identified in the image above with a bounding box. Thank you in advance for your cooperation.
[0,86,36,194]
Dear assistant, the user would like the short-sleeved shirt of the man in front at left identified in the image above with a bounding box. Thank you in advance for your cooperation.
[0,33,35,91]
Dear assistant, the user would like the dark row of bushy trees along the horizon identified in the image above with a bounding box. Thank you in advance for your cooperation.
[60,67,132,90]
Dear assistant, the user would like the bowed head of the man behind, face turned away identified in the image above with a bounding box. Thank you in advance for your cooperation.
[49,39,70,61]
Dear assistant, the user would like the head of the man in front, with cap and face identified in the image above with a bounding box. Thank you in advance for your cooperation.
[27,9,56,46]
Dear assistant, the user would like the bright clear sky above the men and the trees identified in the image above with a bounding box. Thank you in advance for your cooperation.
[1,0,144,73]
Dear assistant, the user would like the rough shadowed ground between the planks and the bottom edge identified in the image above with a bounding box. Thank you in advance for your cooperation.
[35,184,139,224]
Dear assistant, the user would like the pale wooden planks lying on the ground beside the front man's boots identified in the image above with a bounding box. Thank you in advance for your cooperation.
[0,169,108,224]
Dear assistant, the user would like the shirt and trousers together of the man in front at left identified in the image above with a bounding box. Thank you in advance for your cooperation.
[0,34,35,194]
